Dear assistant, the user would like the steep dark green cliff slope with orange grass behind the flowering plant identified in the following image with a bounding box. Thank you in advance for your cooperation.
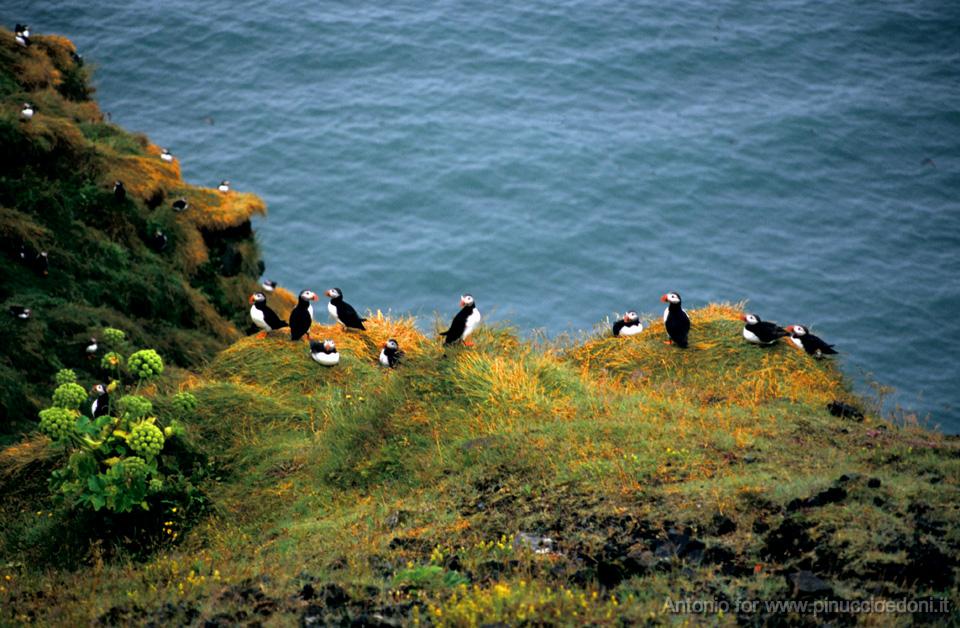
[0,29,265,439]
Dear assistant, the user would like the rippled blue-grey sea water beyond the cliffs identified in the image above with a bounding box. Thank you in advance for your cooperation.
[7,0,960,432]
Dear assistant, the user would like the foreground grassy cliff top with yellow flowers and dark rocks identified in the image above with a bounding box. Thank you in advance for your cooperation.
[0,302,960,625]
